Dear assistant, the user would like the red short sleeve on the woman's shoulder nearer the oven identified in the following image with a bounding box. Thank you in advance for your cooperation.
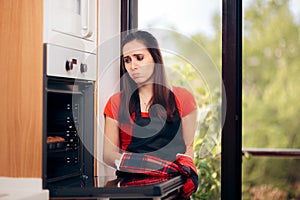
[103,93,120,120]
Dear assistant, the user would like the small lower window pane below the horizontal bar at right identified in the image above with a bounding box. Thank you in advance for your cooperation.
[242,157,300,200]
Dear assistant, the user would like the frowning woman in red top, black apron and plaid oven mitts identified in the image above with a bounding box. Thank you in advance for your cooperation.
[104,31,198,199]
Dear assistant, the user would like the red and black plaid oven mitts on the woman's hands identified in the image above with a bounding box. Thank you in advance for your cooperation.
[119,153,198,200]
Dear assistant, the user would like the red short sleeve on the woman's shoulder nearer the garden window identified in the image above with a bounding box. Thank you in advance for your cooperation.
[173,87,197,117]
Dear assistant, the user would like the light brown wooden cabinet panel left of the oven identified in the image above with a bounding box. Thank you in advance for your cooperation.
[0,0,43,178]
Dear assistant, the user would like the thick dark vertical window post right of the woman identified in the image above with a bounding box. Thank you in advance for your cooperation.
[221,0,243,200]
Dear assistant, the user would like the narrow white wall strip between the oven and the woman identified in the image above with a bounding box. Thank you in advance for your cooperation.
[96,0,121,174]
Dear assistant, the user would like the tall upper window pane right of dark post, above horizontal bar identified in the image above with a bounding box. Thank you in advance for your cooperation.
[243,0,300,148]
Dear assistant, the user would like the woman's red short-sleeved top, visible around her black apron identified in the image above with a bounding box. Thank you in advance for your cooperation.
[104,87,197,150]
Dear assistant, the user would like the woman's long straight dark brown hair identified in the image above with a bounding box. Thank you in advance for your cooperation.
[119,30,175,122]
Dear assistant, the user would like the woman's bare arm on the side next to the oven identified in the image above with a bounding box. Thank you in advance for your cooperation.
[103,116,121,168]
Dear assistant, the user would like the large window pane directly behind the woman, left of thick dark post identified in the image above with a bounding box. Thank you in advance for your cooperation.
[138,0,222,199]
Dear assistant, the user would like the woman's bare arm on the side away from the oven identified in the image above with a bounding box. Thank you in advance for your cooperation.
[182,110,197,158]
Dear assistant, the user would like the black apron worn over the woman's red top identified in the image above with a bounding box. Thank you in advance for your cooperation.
[126,92,186,162]
